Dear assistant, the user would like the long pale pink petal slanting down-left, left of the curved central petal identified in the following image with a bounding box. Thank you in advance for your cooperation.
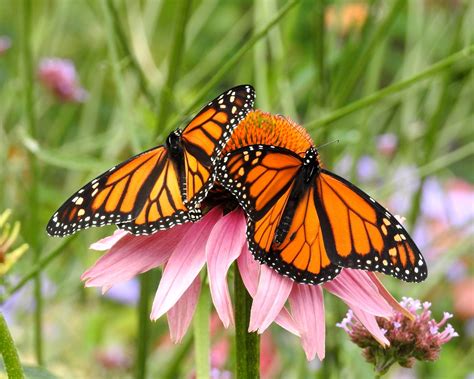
[151,208,222,320]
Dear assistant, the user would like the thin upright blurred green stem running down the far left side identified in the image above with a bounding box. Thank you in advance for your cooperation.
[20,0,43,365]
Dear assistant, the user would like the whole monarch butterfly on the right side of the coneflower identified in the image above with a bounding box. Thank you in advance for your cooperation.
[217,113,427,284]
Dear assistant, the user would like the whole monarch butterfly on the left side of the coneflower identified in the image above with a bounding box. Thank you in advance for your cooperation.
[46,85,255,236]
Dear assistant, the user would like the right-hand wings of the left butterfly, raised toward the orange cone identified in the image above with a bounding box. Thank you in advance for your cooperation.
[182,85,255,207]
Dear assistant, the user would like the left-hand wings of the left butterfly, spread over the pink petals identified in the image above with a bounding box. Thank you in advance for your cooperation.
[46,146,200,237]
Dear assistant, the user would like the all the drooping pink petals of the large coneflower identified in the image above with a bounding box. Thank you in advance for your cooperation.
[82,208,407,360]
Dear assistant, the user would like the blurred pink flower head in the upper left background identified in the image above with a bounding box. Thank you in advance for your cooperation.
[38,58,87,103]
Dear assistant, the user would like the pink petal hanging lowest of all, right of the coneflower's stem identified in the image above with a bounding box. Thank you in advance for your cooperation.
[289,284,326,361]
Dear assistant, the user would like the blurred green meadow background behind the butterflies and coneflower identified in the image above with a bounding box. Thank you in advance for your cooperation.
[0,0,474,378]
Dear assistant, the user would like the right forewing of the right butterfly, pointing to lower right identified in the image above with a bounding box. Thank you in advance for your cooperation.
[315,170,428,282]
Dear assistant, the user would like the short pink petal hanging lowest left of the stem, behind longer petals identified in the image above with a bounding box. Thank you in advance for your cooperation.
[167,277,201,343]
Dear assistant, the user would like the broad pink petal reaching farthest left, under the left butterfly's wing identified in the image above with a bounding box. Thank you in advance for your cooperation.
[81,224,190,288]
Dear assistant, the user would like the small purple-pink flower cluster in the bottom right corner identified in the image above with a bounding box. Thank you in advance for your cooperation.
[337,297,458,373]
